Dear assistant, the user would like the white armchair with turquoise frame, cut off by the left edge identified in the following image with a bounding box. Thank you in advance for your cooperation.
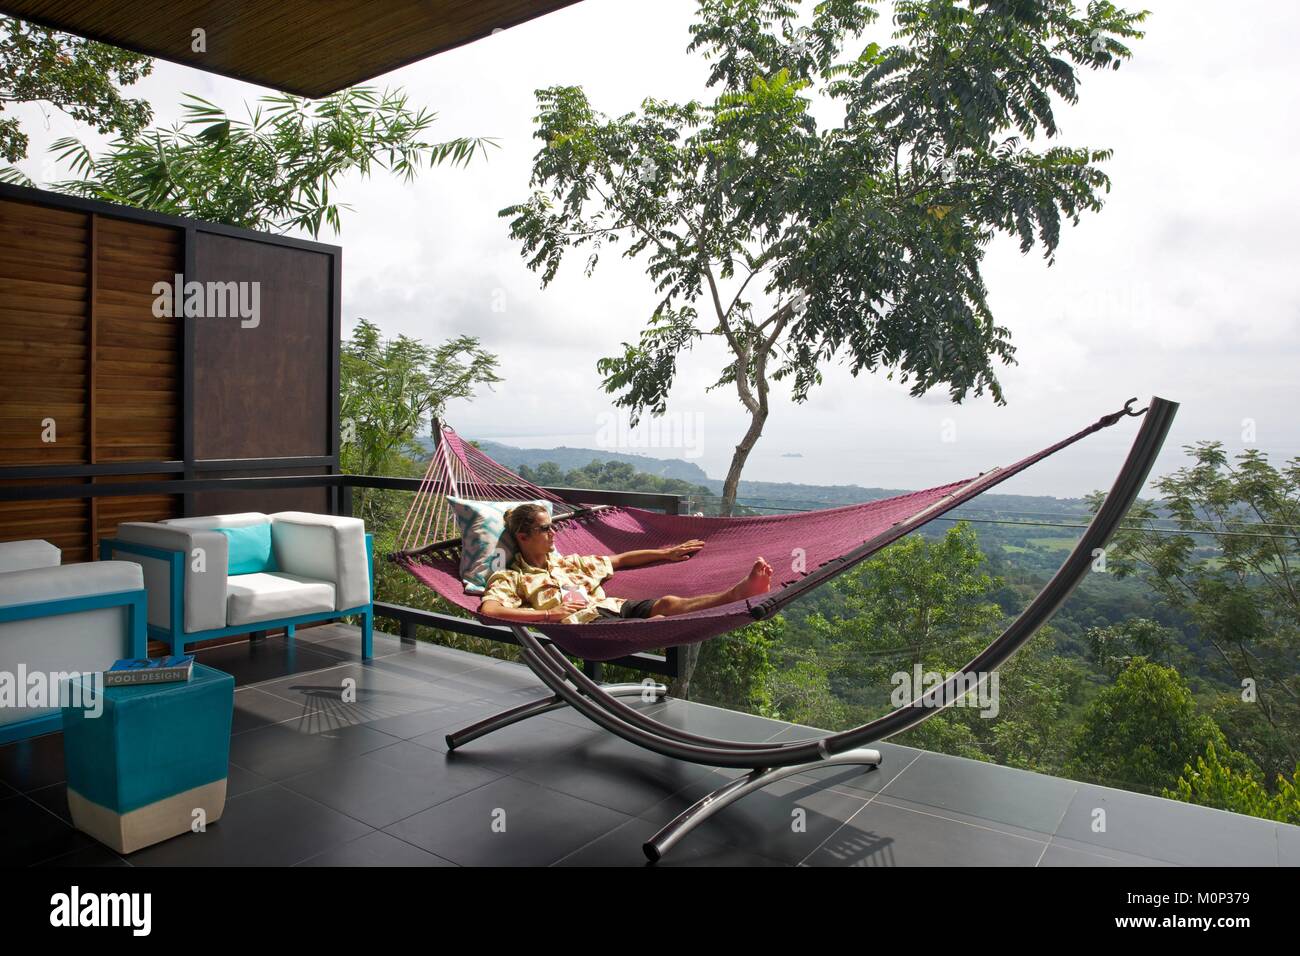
[0,541,146,743]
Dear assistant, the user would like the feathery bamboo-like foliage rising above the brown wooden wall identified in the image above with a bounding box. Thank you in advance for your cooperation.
[41,87,495,237]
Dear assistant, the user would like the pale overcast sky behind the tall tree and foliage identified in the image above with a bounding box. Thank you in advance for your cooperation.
[12,0,1300,497]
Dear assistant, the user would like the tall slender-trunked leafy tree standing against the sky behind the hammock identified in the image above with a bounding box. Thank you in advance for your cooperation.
[501,0,1145,514]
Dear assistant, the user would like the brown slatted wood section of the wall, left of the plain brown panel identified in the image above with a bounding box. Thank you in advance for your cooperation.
[0,199,185,562]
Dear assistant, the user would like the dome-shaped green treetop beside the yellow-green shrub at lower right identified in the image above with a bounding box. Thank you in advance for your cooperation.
[1067,657,1258,793]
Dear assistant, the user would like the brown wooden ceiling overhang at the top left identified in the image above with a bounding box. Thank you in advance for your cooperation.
[0,0,577,98]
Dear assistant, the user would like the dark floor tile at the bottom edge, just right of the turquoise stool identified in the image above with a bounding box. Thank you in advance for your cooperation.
[126,787,371,866]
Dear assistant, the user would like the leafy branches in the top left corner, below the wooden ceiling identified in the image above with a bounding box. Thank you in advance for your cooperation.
[0,17,153,167]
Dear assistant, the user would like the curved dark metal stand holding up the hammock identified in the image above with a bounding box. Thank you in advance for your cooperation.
[436,398,1178,861]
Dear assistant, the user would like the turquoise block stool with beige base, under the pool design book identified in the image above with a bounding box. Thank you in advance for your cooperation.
[64,663,235,853]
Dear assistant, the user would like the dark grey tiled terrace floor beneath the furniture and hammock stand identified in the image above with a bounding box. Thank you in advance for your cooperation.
[0,626,1300,866]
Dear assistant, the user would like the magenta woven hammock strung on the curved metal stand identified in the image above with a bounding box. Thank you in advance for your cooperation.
[389,399,1145,661]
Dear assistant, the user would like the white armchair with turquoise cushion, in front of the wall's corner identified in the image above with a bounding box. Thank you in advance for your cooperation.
[100,511,373,658]
